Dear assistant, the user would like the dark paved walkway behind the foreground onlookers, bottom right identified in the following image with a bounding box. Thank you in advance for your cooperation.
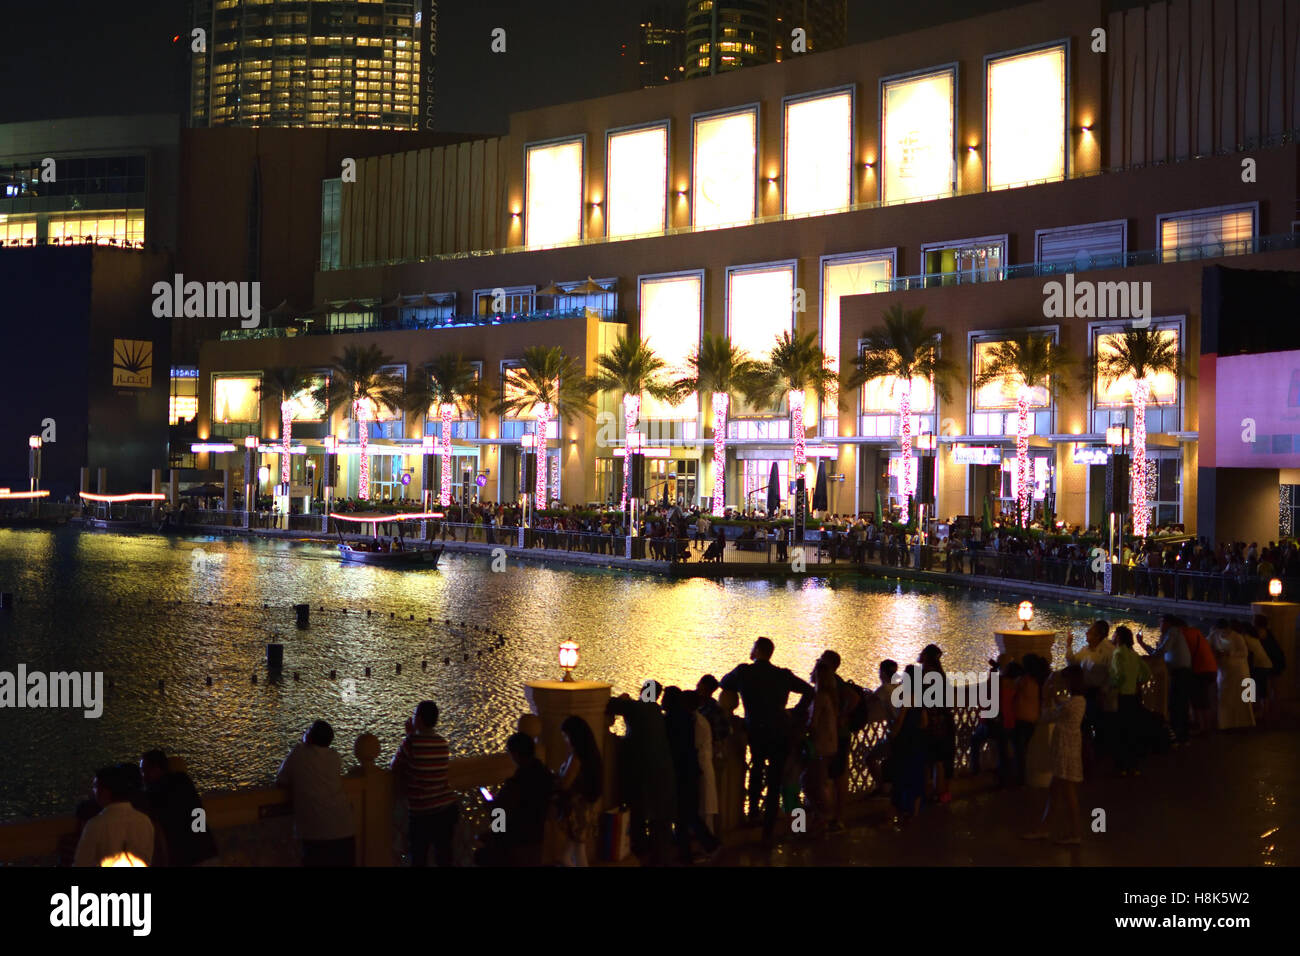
[716,721,1300,866]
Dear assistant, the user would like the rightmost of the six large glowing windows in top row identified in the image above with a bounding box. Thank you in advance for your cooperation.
[984,44,1066,189]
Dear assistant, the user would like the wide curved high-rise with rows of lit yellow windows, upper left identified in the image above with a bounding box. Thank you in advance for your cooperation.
[190,0,437,130]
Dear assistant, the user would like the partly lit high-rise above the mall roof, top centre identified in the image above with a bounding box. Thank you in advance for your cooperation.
[685,0,849,78]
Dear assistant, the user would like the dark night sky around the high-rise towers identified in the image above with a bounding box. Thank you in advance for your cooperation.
[0,0,1140,133]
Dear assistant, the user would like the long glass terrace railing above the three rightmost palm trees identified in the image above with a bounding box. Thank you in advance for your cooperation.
[876,233,1300,293]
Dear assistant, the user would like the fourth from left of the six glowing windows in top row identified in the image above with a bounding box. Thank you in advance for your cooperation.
[784,90,853,215]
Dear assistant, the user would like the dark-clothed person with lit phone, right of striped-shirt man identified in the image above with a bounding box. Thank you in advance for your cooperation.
[476,734,555,866]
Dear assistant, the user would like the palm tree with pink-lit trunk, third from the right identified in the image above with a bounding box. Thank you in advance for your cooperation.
[846,303,957,516]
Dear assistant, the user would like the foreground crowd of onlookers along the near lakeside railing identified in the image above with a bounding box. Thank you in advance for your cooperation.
[64,614,1287,866]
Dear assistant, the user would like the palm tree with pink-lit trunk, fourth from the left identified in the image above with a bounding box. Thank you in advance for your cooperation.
[494,345,595,510]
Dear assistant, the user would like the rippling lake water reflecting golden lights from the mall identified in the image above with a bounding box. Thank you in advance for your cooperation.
[0,529,1153,821]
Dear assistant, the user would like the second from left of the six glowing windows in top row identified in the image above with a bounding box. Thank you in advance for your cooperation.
[605,126,668,238]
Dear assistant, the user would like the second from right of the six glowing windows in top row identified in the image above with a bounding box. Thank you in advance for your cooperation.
[880,69,957,203]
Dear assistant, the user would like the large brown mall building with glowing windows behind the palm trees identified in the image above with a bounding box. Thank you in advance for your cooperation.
[196,0,1300,529]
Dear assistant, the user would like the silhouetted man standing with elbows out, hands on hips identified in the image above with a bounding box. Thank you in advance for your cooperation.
[722,637,813,839]
